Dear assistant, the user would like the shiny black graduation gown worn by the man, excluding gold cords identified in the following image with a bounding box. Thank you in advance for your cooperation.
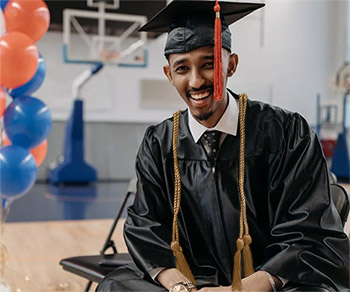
[124,100,349,290]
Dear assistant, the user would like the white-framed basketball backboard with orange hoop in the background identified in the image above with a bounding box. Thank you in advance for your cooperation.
[63,0,147,67]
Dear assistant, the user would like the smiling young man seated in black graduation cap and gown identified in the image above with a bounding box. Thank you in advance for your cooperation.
[97,0,349,292]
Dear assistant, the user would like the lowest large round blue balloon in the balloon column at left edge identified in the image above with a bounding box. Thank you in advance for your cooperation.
[0,145,37,198]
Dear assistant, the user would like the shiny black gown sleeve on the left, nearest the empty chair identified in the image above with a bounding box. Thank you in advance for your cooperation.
[124,127,176,274]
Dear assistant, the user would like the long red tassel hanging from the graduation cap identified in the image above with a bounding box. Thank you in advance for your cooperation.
[214,0,223,101]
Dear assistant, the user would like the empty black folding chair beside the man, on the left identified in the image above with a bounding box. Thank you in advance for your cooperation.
[60,179,136,291]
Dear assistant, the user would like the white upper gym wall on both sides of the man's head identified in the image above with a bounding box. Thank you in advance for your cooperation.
[35,0,348,124]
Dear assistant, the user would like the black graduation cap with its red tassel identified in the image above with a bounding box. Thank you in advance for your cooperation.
[140,0,265,100]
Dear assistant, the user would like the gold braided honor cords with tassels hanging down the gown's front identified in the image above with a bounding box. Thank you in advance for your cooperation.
[171,94,254,291]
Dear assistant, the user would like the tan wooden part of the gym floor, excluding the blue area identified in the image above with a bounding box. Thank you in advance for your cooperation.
[0,220,126,292]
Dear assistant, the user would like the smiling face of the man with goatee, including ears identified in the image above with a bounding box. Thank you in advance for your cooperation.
[164,47,238,127]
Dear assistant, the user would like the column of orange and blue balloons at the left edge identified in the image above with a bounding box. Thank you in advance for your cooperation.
[0,0,51,210]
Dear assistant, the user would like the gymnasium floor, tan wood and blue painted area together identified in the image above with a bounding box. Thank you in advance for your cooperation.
[0,181,350,292]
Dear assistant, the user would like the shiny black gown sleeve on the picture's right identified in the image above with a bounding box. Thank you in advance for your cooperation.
[260,114,349,291]
